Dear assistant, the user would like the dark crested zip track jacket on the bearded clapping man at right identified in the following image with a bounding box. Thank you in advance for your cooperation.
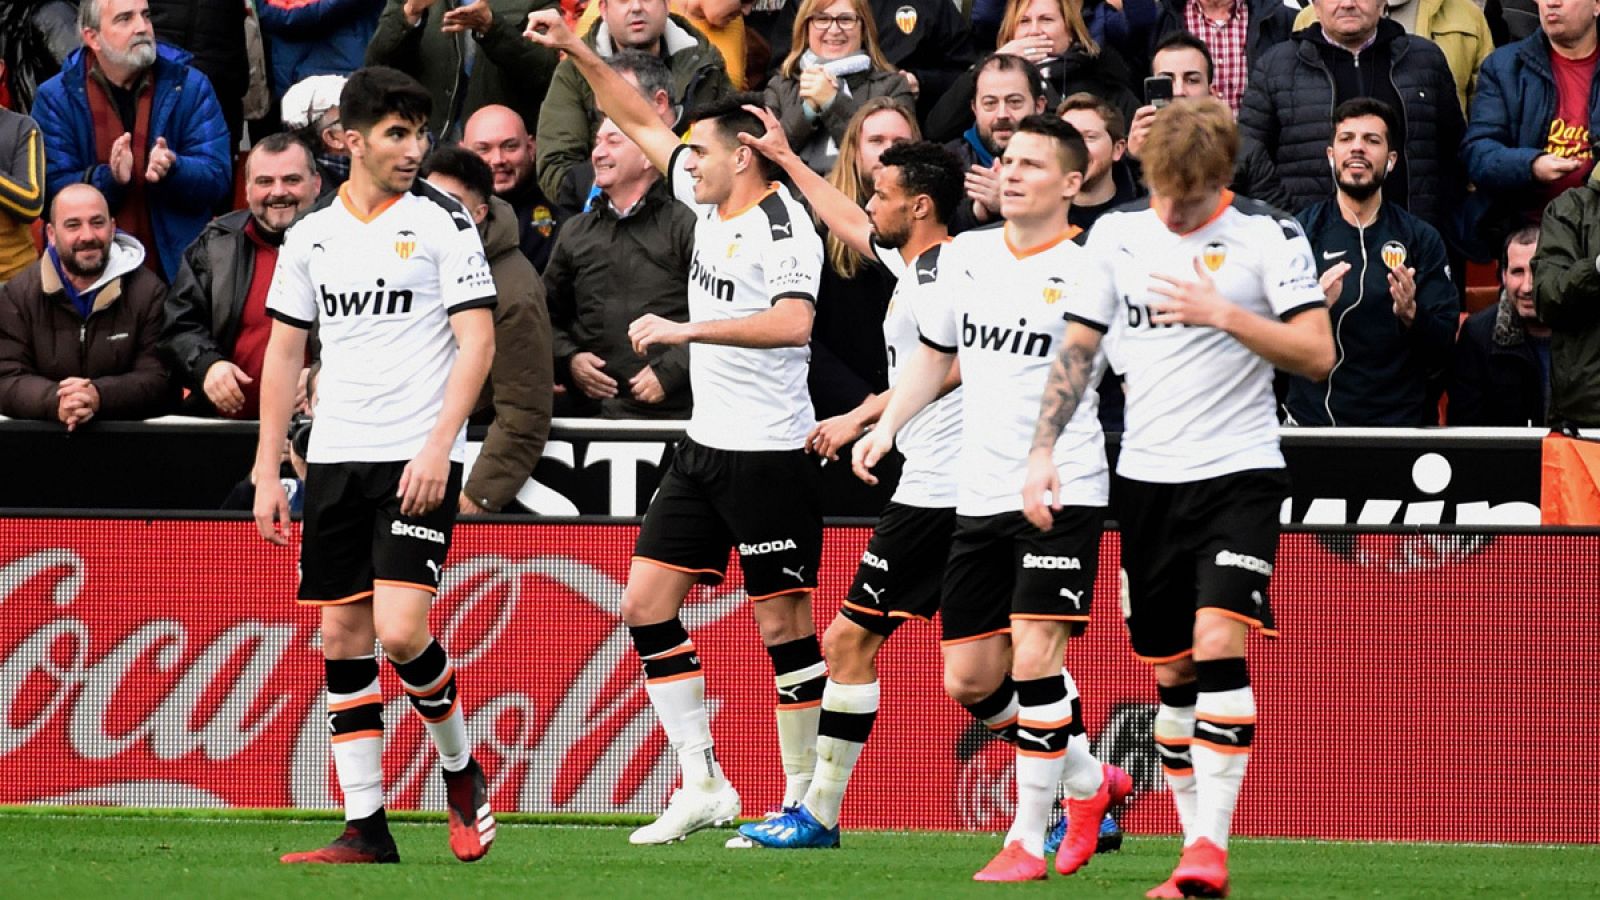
[1286,199,1459,428]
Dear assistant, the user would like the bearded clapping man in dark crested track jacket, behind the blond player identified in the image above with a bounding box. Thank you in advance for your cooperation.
[1286,98,1458,428]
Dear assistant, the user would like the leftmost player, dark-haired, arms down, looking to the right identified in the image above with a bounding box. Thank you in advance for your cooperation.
[254,67,494,863]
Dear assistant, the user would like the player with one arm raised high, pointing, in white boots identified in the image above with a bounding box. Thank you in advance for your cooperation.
[526,10,827,844]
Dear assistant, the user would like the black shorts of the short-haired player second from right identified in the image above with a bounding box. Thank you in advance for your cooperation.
[939,506,1106,644]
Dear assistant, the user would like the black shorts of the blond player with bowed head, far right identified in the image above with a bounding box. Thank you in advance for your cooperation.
[1112,469,1290,663]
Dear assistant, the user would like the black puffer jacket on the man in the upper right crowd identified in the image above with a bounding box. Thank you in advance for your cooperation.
[1238,19,1466,237]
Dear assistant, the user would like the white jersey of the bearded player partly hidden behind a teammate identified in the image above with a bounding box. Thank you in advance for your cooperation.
[874,243,962,509]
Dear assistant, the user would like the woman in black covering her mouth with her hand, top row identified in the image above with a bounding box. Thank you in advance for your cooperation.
[928,0,1139,141]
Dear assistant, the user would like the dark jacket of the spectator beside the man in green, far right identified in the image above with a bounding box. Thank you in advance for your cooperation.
[1450,293,1549,426]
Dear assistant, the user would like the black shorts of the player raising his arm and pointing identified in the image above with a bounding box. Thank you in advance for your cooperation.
[634,437,822,601]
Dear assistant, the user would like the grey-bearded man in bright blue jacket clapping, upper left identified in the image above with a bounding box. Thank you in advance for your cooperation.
[34,0,234,282]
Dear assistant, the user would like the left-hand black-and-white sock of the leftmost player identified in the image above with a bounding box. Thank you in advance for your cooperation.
[323,657,384,823]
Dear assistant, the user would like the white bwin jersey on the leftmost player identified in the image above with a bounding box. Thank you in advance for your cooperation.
[267,178,494,463]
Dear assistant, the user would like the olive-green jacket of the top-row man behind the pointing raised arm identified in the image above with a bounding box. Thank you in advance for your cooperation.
[538,16,733,197]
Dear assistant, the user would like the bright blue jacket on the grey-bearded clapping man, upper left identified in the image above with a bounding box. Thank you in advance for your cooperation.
[34,43,234,283]
